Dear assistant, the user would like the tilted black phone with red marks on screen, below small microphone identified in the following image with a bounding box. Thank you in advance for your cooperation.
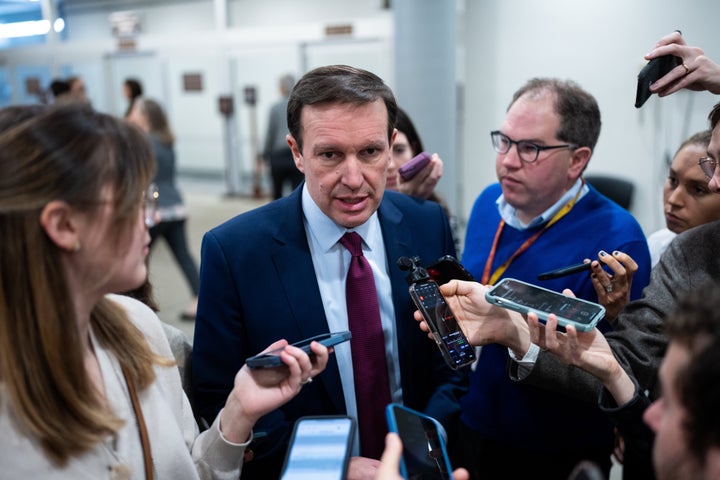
[410,281,475,369]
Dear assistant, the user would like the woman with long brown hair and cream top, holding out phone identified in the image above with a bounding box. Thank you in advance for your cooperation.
[0,105,328,479]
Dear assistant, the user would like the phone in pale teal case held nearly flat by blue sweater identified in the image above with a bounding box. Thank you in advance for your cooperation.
[485,278,605,332]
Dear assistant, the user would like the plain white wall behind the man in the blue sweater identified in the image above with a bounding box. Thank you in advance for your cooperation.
[462,0,720,236]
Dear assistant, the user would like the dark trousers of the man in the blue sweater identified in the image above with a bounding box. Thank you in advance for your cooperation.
[450,422,612,480]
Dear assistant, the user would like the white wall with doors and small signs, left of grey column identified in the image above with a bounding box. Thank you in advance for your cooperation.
[0,0,393,193]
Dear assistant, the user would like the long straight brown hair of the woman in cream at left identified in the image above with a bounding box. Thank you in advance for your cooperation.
[0,105,163,466]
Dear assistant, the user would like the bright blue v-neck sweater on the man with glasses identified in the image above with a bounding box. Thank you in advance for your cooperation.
[461,184,651,452]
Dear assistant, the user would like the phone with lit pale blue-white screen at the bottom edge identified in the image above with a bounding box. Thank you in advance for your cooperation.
[280,415,355,480]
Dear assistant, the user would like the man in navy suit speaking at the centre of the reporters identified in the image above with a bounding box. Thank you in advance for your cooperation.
[192,66,466,479]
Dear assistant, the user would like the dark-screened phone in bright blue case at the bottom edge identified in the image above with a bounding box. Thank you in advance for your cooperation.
[385,403,452,480]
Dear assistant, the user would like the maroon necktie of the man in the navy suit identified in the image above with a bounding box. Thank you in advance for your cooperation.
[340,232,390,459]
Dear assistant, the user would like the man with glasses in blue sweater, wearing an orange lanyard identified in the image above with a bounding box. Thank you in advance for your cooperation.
[455,78,650,478]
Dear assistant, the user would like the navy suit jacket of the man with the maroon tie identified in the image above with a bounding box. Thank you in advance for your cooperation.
[192,185,467,479]
